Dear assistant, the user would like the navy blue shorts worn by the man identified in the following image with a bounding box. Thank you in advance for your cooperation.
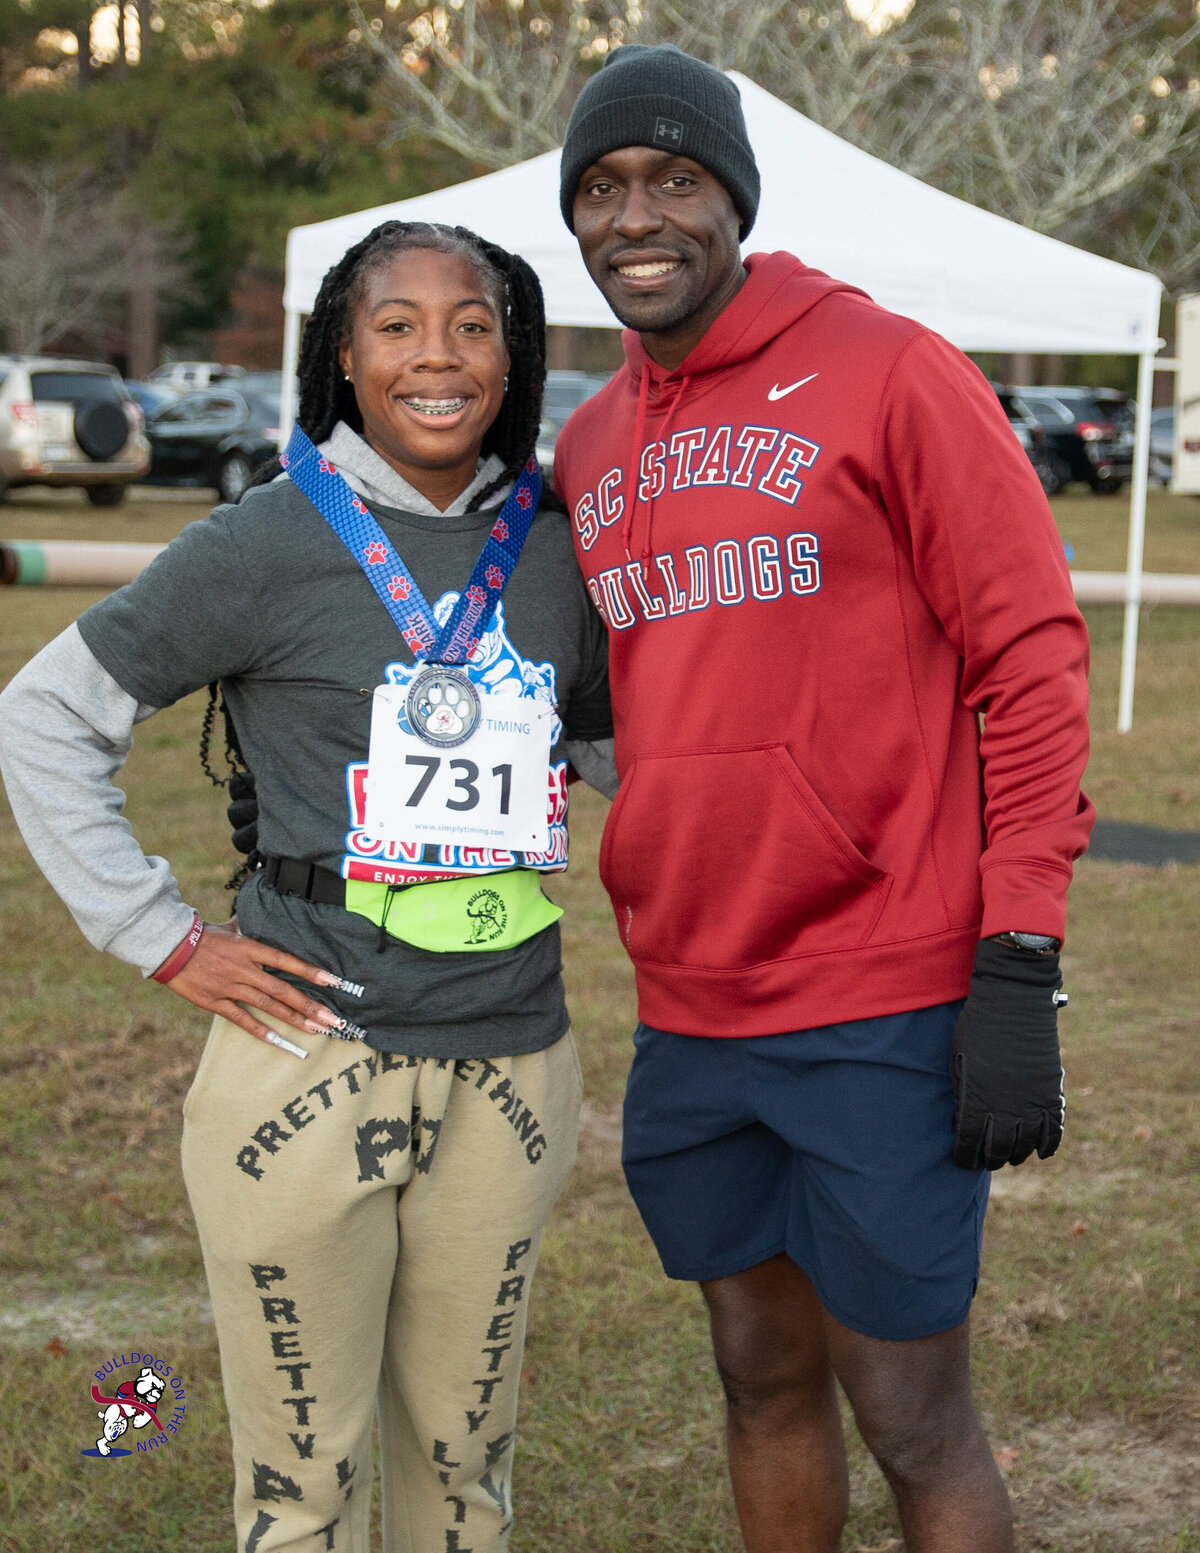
[623,1002,989,1339]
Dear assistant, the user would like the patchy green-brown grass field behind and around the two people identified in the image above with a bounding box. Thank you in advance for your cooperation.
[0,492,1200,1553]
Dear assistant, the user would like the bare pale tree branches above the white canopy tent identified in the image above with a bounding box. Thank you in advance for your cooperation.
[349,0,1200,285]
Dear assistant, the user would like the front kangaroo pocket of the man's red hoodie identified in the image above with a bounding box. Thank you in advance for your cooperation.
[599,744,891,971]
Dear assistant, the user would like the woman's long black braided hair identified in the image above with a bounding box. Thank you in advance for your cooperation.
[200,221,557,890]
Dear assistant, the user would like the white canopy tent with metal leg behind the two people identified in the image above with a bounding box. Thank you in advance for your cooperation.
[281,71,1161,730]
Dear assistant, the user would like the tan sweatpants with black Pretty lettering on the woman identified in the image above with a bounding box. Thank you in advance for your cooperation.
[183,1016,582,1553]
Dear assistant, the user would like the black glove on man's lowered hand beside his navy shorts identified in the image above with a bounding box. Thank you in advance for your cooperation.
[950,938,1065,1169]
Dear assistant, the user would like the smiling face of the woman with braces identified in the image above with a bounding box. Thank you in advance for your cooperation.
[338,248,509,511]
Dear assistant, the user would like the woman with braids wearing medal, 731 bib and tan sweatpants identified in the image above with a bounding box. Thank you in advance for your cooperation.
[0,222,610,1553]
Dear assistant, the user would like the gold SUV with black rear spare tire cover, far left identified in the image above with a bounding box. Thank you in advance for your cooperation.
[0,356,151,506]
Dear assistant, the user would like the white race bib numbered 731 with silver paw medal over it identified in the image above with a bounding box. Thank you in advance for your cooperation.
[363,680,557,853]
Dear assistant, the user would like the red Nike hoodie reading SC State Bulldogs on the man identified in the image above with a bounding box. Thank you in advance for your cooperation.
[554,253,1093,1036]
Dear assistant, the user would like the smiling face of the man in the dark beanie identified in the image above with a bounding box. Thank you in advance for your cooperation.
[571,146,745,368]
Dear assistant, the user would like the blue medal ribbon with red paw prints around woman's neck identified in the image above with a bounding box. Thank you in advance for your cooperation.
[279,426,542,663]
